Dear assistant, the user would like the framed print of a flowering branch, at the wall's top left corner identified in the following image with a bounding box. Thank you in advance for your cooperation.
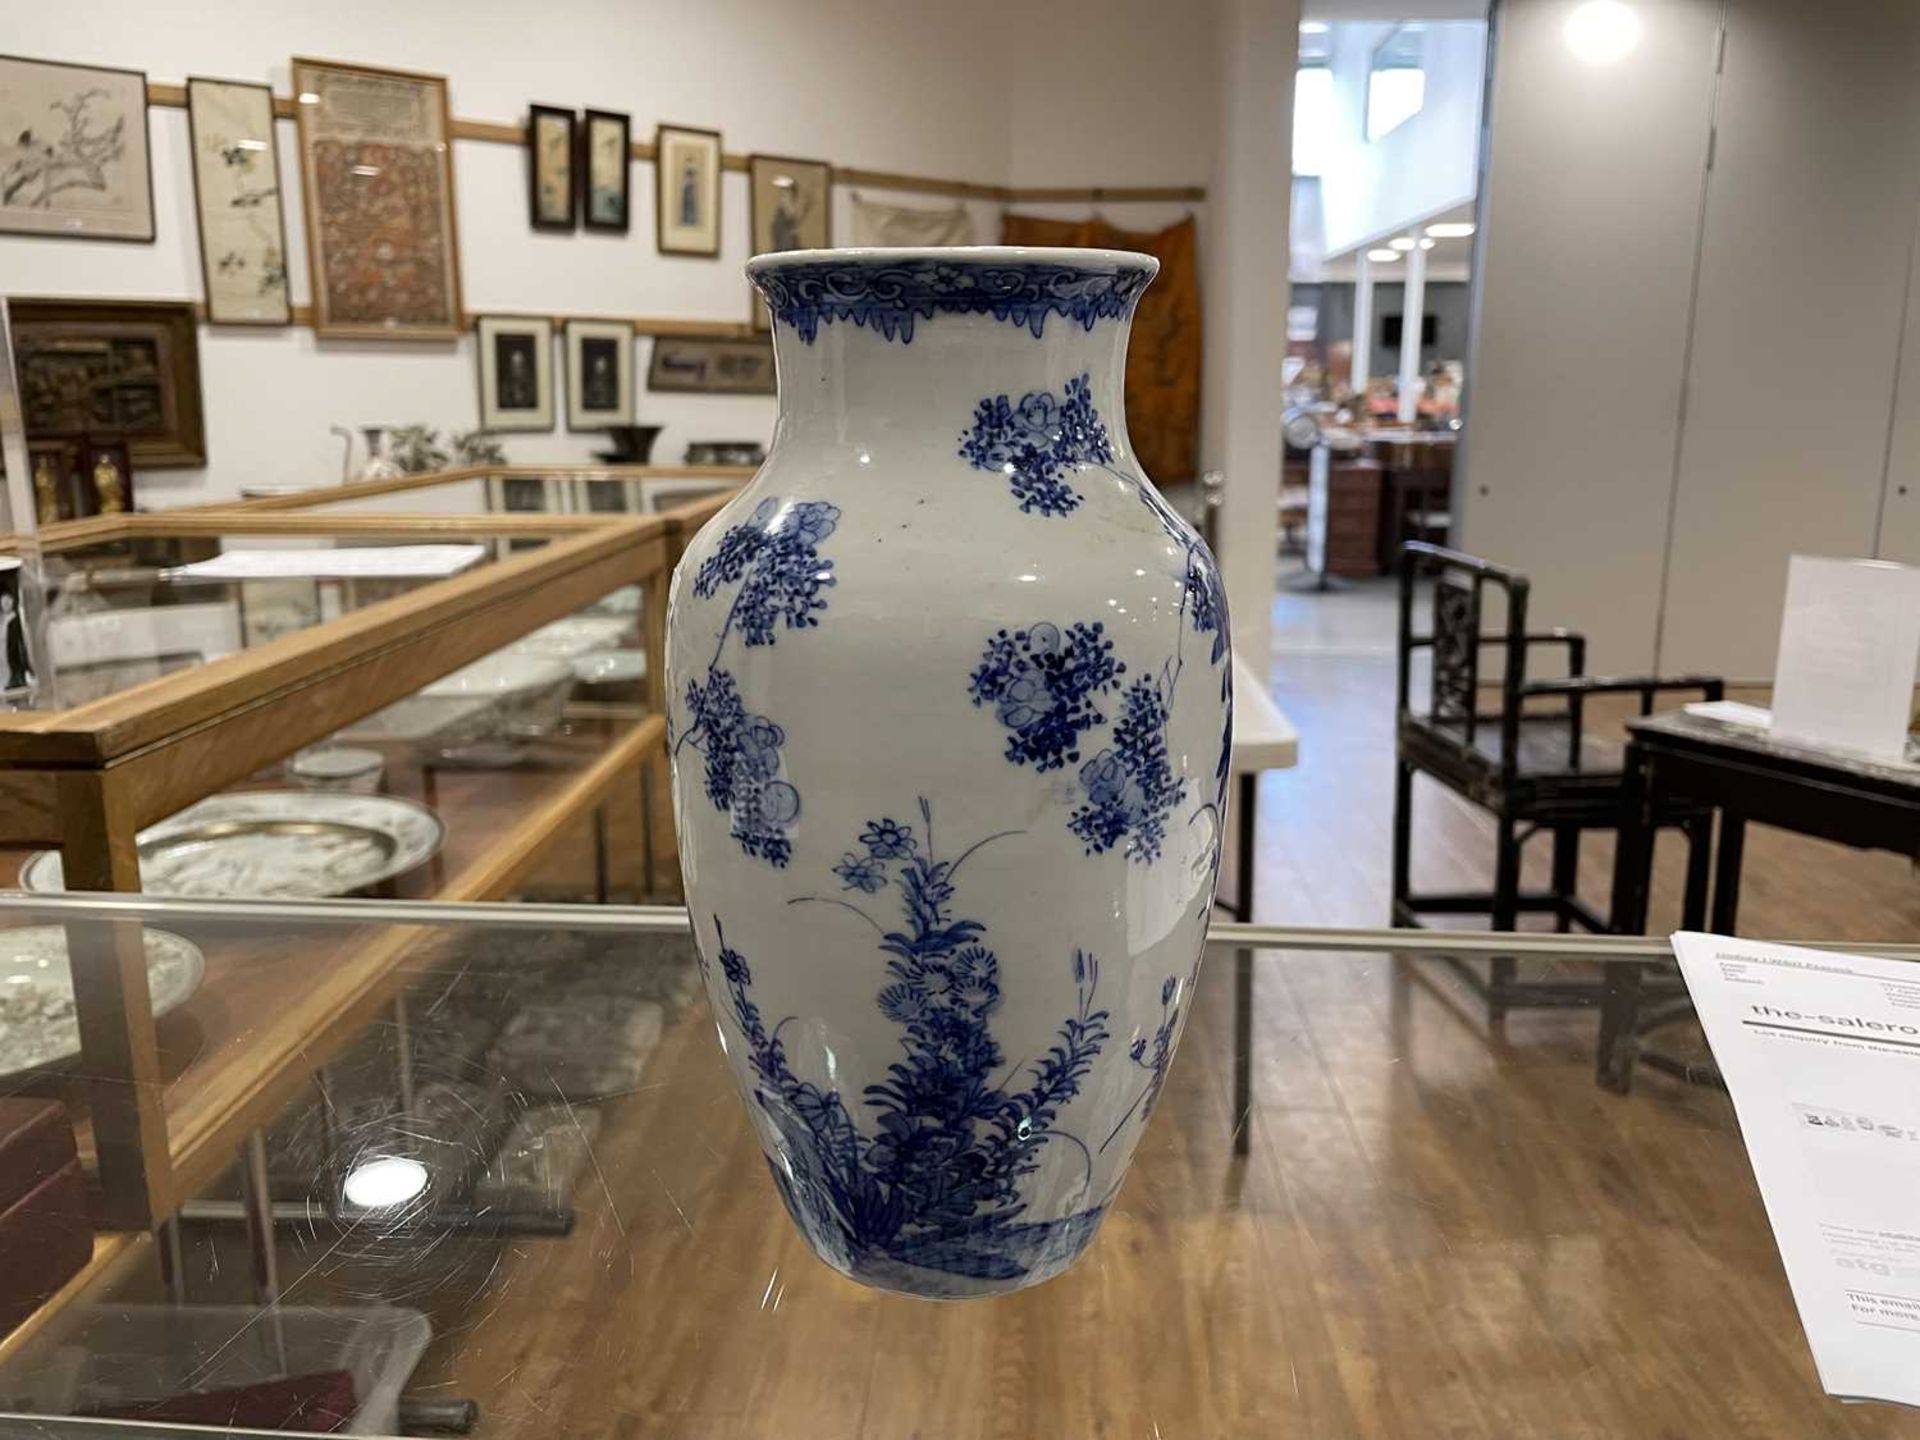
[0,56,154,240]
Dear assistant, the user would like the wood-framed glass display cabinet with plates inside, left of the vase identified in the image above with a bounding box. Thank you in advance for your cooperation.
[0,511,676,1227]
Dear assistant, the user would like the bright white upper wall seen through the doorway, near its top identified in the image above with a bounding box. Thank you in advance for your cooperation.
[1321,21,1486,255]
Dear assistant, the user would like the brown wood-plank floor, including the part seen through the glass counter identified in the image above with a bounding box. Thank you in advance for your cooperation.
[161,629,1920,1440]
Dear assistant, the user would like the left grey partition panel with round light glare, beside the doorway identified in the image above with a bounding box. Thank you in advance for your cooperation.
[1455,0,1720,670]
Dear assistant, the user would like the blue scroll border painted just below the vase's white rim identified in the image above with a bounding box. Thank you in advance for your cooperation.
[755,259,1154,346]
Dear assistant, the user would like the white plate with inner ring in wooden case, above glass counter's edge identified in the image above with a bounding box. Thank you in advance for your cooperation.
[19,789,445,900]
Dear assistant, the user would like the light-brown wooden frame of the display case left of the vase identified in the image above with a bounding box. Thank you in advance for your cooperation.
[0,511,674,1231]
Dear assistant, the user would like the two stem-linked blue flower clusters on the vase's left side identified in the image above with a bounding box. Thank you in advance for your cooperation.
[674,497,841,868]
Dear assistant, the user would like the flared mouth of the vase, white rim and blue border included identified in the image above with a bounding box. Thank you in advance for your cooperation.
[747,246,1160,344]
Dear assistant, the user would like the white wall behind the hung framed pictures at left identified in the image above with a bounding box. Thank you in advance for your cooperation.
[0,0,1021,505]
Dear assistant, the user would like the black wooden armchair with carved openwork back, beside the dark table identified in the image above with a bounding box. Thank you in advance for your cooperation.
[1394,541,1724,1023]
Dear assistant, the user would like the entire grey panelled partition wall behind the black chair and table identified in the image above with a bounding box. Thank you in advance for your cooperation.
[1459,0,1920,680]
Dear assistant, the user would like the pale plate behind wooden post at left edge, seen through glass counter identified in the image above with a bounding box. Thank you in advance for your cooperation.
[0,925,207,1075]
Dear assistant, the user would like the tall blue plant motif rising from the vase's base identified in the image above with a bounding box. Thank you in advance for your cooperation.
[703,801,1110,1292]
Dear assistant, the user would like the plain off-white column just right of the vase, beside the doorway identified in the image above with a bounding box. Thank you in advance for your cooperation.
[1202,0,1300,680]
